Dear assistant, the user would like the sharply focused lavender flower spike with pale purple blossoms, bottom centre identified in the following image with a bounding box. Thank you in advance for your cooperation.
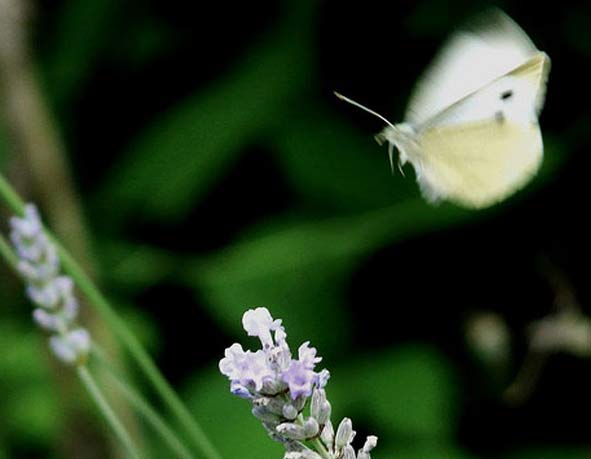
[219,308,377,459]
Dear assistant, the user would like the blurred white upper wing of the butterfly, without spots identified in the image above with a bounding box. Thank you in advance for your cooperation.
[405,9,539,126]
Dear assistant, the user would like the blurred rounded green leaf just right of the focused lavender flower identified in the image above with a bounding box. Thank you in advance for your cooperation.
[327,346,459,444]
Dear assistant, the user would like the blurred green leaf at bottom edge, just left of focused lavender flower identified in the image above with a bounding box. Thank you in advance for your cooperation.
[185,365,283,459]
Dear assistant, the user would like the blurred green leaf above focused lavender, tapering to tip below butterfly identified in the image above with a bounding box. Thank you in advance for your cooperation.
[184,198,470,354]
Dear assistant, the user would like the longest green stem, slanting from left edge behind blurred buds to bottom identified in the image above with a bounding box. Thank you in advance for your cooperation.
[0,174,221,459]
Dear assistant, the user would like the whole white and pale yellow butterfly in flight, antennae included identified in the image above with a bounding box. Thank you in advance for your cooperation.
[335,10,550,208]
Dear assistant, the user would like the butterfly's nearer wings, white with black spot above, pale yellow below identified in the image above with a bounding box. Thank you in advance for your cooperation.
[410,52,549,208]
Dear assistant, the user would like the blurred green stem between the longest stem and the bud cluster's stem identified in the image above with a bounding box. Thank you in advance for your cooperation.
[92,345,195,459]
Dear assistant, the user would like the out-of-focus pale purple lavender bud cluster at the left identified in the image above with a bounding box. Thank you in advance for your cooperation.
[10,204,90,364]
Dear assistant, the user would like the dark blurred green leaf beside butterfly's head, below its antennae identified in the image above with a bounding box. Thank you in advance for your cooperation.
[271,104,419,211]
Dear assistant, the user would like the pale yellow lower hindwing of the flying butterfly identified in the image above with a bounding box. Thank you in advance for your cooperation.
[413,120,543,208]
